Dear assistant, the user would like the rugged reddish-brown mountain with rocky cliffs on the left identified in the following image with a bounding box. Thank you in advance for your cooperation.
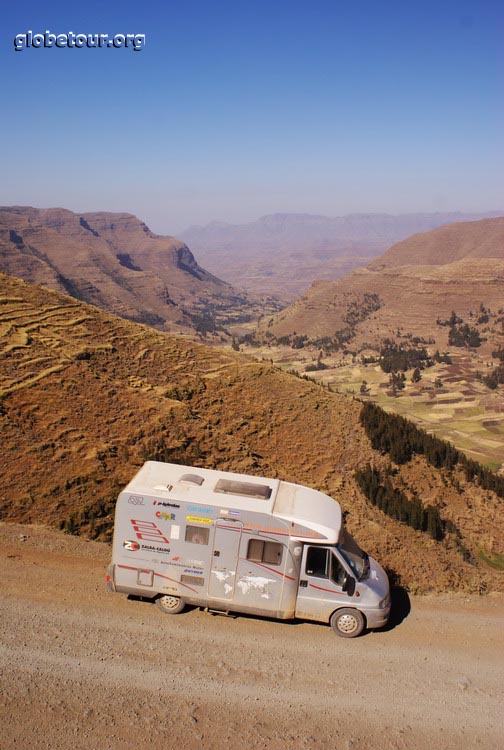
[0,206,268,331]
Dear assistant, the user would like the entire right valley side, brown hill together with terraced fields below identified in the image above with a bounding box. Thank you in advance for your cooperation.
[234,218,504,469]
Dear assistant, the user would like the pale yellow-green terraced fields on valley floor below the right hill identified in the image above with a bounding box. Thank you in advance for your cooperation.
[242,346,504,470]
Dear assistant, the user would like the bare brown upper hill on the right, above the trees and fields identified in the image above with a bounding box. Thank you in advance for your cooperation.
[266,219,504,348]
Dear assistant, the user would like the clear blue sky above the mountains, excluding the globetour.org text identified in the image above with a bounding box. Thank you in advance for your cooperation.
[0,0,504,233]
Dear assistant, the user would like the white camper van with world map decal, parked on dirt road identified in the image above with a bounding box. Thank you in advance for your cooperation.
[107,461,390,638]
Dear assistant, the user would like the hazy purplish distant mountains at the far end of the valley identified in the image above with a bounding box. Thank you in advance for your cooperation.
[180,211,504,300]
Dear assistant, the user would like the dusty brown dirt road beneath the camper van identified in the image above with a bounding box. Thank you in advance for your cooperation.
[0,524,504,750]
